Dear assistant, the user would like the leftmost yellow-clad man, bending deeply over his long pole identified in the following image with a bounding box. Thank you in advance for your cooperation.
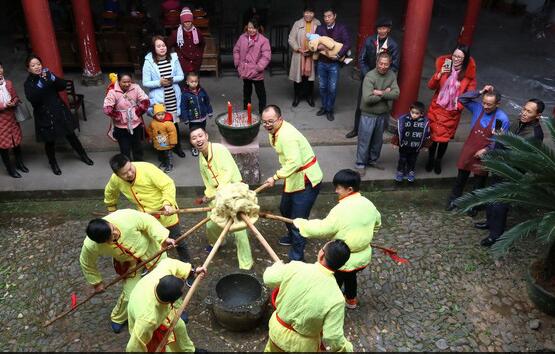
[79,209,175,333]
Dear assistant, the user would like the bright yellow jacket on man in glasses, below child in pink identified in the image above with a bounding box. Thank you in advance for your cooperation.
[104,162,179,227]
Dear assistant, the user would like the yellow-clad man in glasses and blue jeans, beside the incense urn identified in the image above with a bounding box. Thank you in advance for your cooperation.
[262,105,322,261]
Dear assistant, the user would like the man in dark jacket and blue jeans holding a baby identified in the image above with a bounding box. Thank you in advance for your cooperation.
[316,8,351,121]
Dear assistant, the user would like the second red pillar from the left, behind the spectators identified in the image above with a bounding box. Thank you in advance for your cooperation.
[72,0,102,85]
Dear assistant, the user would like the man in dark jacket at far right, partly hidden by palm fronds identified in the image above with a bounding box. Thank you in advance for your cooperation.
[474,98,545,247]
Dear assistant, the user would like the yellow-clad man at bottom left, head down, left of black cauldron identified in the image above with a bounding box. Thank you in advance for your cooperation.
[126,258,206,353]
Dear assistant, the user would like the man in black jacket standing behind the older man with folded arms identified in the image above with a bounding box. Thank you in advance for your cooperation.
[345,18,400,138]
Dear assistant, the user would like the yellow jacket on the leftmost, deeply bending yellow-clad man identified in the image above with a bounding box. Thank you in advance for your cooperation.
[79,209,169,285]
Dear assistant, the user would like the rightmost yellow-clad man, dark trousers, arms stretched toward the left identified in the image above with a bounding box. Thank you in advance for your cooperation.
[294,169,382,309]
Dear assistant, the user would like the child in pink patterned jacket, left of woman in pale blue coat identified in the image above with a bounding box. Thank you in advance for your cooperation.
[104,73,150,161]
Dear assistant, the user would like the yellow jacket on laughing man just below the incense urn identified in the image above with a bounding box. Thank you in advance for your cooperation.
[198,143,243,198]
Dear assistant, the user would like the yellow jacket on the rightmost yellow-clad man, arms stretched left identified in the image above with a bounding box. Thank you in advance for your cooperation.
[294,193,382,272]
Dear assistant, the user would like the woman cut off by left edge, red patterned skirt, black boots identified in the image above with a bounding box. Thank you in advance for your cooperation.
[0,63,29,178]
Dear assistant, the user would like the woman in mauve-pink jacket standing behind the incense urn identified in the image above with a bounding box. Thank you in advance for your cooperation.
[233,19,272,114]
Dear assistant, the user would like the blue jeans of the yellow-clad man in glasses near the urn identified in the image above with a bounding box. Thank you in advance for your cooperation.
[279,183,320,261]
